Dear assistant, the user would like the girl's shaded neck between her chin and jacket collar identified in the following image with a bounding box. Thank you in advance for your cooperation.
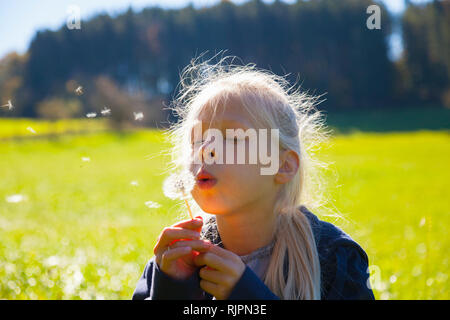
[216,195,276,256]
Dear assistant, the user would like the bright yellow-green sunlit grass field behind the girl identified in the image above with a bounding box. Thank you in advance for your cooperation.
[0,115,450,299]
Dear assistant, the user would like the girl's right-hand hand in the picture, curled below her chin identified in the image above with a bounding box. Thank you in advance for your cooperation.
[194,245,245,300]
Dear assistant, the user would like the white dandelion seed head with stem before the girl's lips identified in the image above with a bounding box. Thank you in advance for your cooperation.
[163,170,195,219]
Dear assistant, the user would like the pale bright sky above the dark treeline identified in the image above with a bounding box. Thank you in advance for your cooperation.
[0,0,427,58]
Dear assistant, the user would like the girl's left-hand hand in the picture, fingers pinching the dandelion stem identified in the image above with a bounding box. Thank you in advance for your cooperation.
[153,217,210,279]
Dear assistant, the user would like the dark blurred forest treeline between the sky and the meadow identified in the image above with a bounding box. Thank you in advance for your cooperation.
[0,0,450,124]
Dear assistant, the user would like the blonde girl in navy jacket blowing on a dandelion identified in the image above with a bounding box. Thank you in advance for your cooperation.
[133,58,374,300]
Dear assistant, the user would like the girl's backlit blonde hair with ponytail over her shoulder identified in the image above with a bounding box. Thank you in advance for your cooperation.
[168,56,329,300]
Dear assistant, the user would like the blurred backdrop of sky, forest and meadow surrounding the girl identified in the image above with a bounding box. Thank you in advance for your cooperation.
[0,0,450,299]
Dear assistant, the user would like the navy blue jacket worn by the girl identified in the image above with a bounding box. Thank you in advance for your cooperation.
[132,206,374,300]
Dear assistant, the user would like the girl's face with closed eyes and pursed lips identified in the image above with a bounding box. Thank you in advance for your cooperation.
[190,97,279,214]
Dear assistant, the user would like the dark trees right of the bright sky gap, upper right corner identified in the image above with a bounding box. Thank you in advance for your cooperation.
[399,0,450,106]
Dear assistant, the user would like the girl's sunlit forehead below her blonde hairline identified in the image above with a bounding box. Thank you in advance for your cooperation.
[195,95,252,127]
